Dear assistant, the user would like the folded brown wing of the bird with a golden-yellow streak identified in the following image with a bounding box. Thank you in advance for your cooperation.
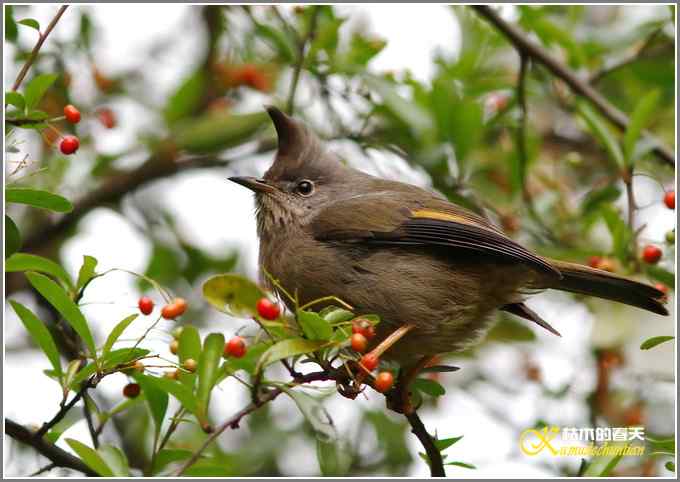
[310,191,561,278]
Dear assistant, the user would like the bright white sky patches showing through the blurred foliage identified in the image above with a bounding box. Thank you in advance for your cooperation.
[3,4,674,477]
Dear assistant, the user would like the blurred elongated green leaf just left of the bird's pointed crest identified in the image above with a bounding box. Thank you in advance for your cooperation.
[173,112,268,154]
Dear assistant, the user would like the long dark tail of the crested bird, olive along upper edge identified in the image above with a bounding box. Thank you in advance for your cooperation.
[547,259,668,315]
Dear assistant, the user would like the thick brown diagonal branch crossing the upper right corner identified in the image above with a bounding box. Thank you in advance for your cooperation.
[471,5,675,167]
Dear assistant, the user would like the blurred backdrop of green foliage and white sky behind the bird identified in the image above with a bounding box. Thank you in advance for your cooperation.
[3,4,676,477]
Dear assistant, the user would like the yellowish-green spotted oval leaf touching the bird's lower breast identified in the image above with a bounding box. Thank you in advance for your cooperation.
[203,274,265,318]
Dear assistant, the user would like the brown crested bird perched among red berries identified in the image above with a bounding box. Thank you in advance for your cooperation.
[230,106,668,376]
